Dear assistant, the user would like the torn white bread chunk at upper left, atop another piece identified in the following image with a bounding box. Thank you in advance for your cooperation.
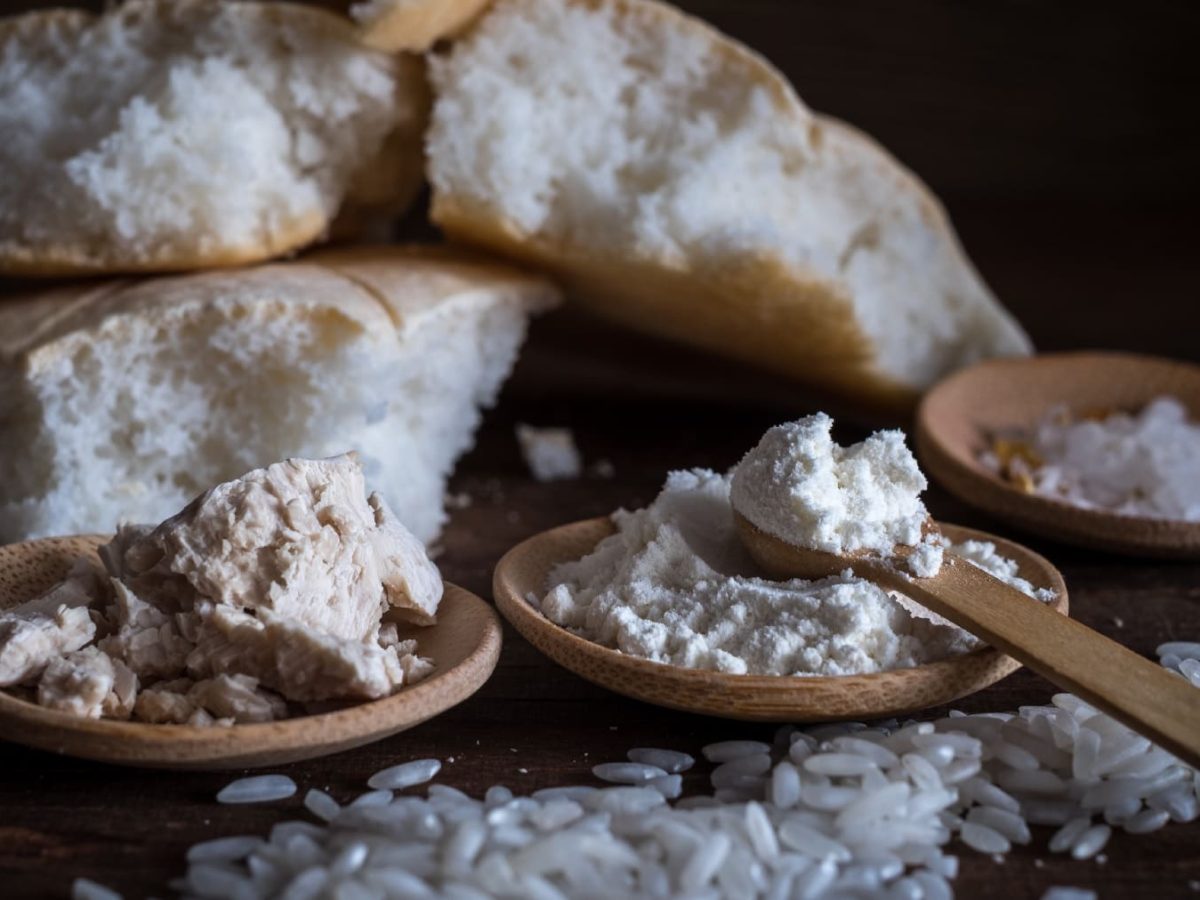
[0,0,432,276]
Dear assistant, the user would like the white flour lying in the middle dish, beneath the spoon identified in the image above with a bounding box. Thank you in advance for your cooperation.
[532,469,1049,676]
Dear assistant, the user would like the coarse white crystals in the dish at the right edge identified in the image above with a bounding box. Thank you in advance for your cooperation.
[980,396,1200,522]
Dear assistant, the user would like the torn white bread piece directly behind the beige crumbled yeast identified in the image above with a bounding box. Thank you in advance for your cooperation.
[0,246,557,544]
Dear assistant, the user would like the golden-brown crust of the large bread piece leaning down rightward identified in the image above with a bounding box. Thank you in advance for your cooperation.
[431,0,1028,416]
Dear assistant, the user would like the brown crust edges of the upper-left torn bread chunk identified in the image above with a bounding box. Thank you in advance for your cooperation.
[0,0,430,278]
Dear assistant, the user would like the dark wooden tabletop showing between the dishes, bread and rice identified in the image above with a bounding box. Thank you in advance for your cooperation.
[0,232,1200,898]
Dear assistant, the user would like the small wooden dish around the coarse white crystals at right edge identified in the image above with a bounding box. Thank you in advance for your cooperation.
[917,353,1200,559]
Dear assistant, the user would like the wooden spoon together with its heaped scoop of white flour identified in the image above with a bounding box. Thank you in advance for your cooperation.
[730,414,1200,766]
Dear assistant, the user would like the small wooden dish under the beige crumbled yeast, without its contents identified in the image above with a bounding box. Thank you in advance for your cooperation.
[0,535,500,769]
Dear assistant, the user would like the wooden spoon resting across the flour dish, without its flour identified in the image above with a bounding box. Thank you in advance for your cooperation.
[734,512,1200,766]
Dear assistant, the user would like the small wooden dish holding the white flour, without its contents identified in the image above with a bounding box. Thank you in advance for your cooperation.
[492,517,1068,722]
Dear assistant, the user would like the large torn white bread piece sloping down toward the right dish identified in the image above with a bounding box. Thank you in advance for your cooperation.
[427,0,1030,407]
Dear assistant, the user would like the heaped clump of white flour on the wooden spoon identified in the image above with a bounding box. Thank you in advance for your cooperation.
[732,413,944,577]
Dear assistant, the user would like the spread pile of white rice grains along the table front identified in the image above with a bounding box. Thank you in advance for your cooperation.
[174,644,1200,900]
